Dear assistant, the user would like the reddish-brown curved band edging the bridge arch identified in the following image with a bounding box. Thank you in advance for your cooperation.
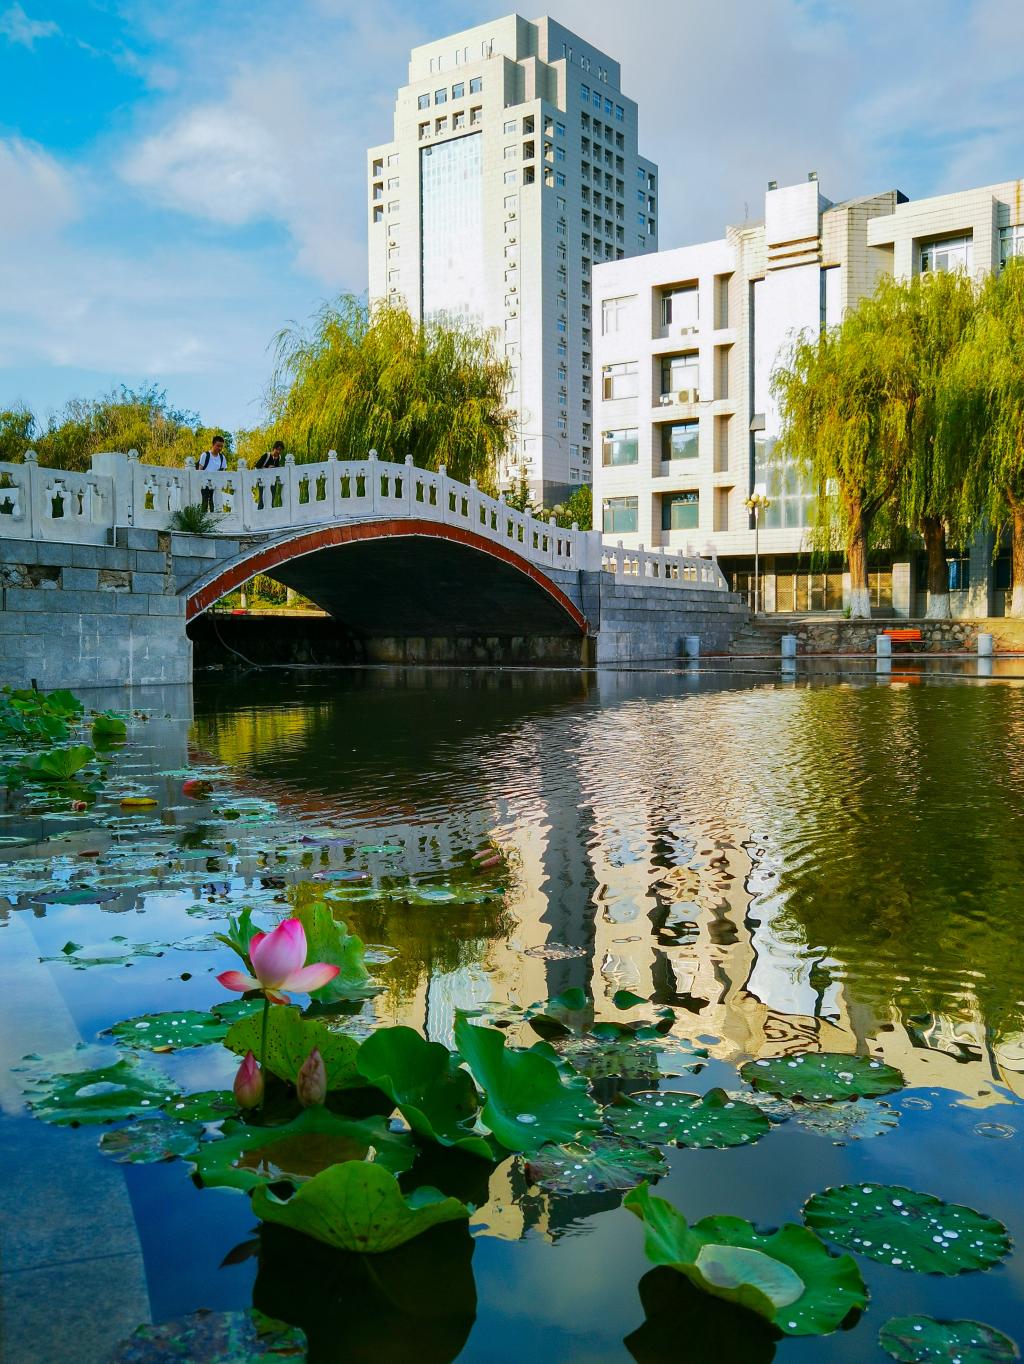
[179,521,588,634]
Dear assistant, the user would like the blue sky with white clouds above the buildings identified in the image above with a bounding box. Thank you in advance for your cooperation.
[0,0,1024,430]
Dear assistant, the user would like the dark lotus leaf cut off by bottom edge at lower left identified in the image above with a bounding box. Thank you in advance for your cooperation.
[109,1308,305,1364]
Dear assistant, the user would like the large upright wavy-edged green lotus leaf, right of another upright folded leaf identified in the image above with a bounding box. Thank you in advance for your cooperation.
[455,1013,600,1155]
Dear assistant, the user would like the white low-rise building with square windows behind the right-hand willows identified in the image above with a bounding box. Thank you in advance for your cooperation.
[594,176,1024,615]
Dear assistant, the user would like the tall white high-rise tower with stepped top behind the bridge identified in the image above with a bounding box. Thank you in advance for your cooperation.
[367,15,659,505]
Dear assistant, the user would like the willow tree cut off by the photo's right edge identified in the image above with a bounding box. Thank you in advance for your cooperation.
[941,259,1024,617]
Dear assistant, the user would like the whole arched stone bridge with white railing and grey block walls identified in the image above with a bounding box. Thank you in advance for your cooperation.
[0,453,744,686]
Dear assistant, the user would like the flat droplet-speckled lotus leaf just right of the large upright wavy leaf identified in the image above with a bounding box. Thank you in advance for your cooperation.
[604,1090,772,1147]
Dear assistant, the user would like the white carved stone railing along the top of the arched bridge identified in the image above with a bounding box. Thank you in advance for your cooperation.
[0,450,728,591]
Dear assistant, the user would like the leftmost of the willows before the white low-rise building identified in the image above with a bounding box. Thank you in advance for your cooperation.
[772,307,909,618]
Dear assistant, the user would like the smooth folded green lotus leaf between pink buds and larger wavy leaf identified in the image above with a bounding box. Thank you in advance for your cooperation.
[356,1027,494,1161]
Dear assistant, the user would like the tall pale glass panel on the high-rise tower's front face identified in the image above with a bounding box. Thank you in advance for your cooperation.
[420,132,484,323]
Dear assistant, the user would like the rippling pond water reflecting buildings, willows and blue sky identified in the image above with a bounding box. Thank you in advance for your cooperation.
[0,670,1024,1364]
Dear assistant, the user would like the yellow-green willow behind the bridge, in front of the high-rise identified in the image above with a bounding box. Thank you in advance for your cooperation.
[270,295,515,487]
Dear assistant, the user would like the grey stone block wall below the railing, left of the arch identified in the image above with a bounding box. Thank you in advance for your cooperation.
[0,529,192,690]
